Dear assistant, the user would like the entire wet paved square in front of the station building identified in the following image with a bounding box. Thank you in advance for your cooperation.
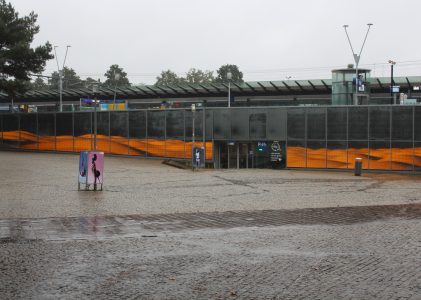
[0,152,421,299]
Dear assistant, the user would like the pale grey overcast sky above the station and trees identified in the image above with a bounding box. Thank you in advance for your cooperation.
[9,0,421,84]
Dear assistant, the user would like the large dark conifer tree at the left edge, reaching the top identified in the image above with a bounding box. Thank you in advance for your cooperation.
[0,0,54,97]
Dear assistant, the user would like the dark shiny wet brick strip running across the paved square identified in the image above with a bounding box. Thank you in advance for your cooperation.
[0,204,421,243]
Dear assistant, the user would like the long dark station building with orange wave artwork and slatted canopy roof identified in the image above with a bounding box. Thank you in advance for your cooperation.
[0,68,421,172]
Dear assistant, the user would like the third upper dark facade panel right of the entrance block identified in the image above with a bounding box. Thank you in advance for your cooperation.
[327,107,347,141]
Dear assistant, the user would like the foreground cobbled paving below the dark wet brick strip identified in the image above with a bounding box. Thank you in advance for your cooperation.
[0,214,421,299]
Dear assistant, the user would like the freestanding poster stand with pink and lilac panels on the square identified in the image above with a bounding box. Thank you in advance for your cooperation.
[78,151,104,191]
